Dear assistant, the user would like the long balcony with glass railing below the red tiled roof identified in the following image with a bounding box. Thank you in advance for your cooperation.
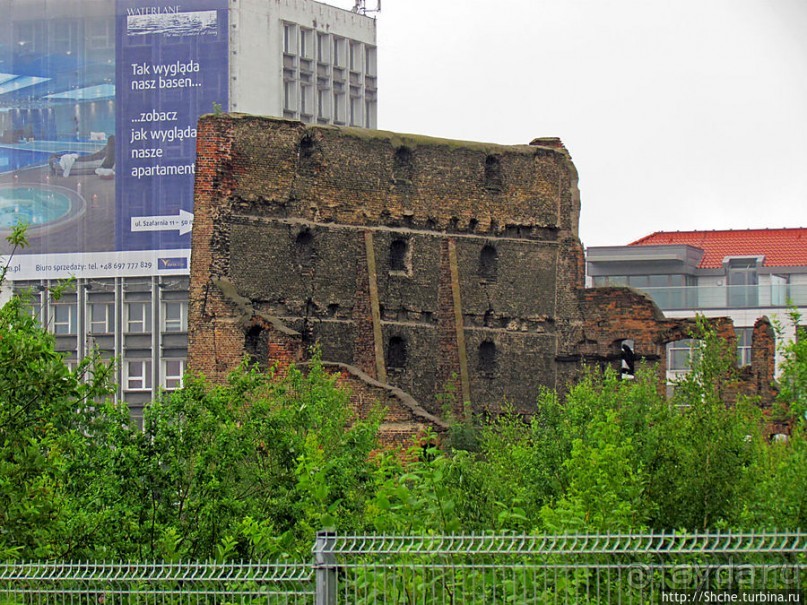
[620,284,807,311]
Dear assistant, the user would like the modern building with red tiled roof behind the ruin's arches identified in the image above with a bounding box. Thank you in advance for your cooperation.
[586,228,807,375]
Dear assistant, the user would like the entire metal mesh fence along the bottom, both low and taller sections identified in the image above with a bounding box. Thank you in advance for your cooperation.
[0,532,807,605]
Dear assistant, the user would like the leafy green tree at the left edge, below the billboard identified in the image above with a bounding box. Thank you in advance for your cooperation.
[0,227,118,557]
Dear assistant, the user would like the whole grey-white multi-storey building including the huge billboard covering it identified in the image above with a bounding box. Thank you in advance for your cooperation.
[0,0,378,415]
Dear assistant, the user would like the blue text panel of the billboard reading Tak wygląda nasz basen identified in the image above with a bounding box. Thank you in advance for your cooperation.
[116,0,228,250]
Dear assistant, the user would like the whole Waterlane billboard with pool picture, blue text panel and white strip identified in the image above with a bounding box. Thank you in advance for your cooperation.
[0,0,228,279]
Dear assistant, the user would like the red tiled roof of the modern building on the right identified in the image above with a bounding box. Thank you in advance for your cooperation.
[628,228,807,269]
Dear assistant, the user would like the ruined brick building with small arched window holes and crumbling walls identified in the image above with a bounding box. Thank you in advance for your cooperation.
[189,115,773,432]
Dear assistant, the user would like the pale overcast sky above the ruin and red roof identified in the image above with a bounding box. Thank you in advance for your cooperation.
[328,0,807,246]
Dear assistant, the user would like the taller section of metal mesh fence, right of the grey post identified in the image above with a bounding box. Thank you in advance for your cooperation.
[315,533,807,604]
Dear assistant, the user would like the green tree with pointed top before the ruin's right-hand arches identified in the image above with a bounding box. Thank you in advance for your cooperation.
[648,317,763,531]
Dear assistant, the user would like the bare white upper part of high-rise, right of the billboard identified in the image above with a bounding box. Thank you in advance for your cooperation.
[230,0,378,128]
